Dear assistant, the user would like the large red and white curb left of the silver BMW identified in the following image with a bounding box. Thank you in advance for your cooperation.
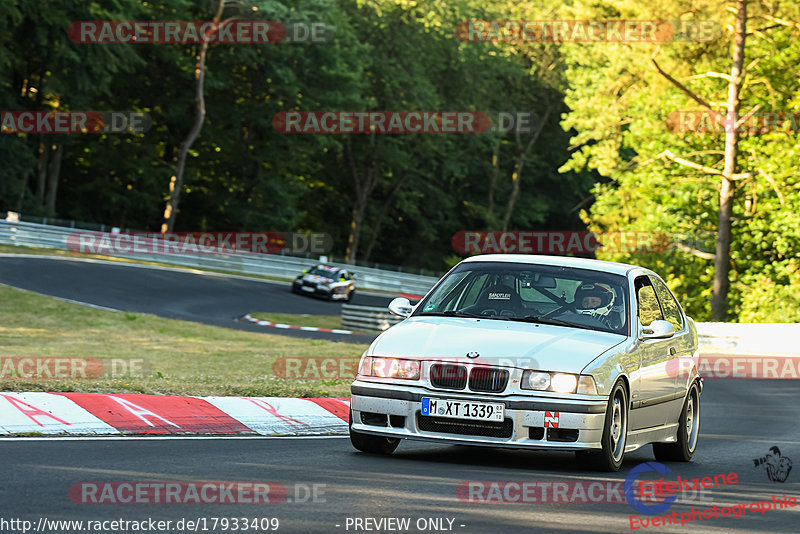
[0,392,350,439]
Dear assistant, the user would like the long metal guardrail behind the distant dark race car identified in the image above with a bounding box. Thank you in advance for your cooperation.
[0,220,438,295]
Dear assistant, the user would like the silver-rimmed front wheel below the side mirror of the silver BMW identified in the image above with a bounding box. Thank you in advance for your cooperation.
[576,380,628,472]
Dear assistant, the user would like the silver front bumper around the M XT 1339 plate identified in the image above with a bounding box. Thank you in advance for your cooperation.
[350,380,608,451]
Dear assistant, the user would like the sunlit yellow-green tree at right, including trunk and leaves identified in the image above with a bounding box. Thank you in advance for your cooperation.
[564,2,798,320]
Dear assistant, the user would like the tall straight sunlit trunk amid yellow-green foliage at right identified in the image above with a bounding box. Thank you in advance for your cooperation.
[711,0,747,321]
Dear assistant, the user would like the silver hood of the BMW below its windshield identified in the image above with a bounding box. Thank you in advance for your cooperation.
[369,317,626,373]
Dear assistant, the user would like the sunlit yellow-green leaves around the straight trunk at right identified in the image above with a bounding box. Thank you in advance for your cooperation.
[562,0,800,321]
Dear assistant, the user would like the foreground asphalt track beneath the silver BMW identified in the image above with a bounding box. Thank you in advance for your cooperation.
[0,380,800,534]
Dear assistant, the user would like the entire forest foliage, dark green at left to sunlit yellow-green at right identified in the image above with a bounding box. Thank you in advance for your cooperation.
[0,0,800,320]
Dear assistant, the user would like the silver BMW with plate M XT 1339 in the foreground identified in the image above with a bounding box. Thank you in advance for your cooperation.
[350,254,702,471]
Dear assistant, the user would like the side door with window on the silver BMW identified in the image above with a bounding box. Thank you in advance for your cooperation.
[630,275,675,430]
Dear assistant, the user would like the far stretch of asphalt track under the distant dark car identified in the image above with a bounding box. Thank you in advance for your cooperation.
[0,255,392,343]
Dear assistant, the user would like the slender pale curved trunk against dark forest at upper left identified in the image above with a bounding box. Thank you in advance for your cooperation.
[161,0,225,234]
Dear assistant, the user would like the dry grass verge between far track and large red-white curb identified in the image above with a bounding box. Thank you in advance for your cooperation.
[0,285,367,397]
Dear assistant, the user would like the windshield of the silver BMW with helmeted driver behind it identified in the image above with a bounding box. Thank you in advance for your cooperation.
[414,262,628,335]
